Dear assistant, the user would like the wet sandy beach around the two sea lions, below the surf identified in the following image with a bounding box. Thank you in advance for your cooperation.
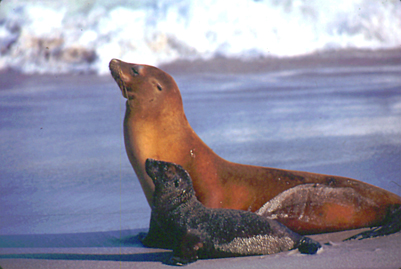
[0,50,401,269]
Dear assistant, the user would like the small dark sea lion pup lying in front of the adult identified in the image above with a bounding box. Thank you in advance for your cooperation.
[145,159,321,264]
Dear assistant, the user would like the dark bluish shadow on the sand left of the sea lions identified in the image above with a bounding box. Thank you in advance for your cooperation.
[0,229,171,263]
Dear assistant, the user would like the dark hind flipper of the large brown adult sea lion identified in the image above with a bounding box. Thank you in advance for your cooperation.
[344,206,401,241]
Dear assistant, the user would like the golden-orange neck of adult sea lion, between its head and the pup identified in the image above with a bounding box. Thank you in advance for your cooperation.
[124,106,207,205]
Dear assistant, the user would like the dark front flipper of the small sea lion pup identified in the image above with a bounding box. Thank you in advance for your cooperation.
[170,230,203,265]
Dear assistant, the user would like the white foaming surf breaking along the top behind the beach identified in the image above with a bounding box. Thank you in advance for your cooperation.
[0,0,401,74]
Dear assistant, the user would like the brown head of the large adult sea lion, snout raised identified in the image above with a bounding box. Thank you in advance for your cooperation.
[109,59,182,114]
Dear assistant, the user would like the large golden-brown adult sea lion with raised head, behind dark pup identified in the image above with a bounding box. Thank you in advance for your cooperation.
[109,59,401,237]
